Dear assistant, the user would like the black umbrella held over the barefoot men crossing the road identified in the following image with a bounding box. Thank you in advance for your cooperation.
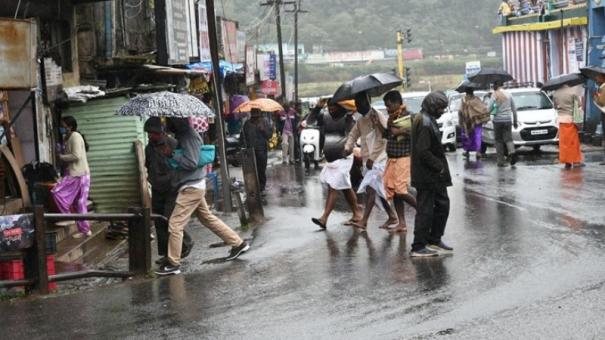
[332,73,403,102]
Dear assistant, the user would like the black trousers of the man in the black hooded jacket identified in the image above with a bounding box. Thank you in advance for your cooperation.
[412,187,450,251]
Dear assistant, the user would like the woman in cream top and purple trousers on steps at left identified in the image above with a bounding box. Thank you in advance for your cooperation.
[52,116,92,238]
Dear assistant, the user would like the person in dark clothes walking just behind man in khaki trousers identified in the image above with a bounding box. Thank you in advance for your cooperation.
[145,117,193,265]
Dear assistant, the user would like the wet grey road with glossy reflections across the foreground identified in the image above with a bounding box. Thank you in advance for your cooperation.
[0,147,605,339]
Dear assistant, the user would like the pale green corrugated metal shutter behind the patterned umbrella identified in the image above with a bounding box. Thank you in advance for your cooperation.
[64,97,146,212]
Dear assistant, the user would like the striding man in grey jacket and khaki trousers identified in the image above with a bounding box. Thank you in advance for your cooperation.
[155,117,250,275]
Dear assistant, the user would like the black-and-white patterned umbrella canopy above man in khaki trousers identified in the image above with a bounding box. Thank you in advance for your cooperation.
[117,91,214,118]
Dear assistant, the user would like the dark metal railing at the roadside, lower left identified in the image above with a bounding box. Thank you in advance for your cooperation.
[0,206,166,294]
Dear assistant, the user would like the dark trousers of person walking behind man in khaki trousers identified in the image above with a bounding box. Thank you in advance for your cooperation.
[151,191,193,256]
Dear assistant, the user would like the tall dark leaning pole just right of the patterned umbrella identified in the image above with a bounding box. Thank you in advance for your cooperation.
[206,0,232,212]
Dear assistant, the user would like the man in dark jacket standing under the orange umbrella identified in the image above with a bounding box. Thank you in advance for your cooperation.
[240,109,273,192]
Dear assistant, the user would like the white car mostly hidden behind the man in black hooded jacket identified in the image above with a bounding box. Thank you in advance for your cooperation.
[372,92,456,151]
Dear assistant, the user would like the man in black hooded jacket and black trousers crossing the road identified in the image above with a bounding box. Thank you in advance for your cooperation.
[411,91,453,257]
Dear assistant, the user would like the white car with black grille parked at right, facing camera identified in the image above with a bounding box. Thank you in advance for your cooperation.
[481,88,559,150]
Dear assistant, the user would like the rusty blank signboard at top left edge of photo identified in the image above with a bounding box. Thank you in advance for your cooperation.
[0,18,38,89]
